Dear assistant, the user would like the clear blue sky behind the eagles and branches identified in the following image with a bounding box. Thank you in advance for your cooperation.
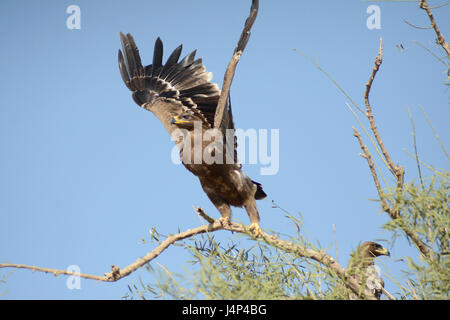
[0,0,450,299]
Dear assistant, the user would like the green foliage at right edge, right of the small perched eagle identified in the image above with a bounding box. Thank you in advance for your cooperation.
[384,171,450,299]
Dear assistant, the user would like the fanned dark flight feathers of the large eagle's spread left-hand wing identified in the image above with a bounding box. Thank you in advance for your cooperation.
[119,33,220,124]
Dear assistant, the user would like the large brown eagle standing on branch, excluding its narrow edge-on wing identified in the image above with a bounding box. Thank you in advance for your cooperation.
[118,33,266,237]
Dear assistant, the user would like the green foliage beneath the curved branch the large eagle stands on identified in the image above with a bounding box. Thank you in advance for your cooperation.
[124,212,366,300]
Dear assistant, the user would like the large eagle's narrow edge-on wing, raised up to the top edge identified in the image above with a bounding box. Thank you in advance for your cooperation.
[214,0,259,128]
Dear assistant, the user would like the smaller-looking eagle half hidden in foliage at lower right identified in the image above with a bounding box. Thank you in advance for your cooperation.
[347,241,390,299]
